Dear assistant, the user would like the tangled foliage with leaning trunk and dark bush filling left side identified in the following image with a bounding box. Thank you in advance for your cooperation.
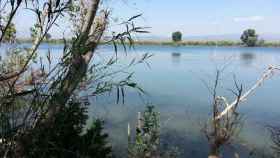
[0,0,149,157]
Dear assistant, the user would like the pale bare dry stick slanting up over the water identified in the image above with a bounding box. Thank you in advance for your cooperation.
[215,66,280,120]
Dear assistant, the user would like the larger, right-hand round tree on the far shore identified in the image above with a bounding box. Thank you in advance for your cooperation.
[240,29,258,47]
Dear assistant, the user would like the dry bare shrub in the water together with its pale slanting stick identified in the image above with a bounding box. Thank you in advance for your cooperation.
[203,66,280,158]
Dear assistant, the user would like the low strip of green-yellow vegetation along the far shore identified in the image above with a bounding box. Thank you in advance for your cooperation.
[17,39,280,47]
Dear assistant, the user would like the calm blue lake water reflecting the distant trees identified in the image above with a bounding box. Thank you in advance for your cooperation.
[2,45,280,157]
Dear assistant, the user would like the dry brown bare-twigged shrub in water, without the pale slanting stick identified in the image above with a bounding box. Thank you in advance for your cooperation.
[203,71,243,158]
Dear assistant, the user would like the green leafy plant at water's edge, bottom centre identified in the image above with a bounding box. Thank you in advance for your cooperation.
[128,106,180,158]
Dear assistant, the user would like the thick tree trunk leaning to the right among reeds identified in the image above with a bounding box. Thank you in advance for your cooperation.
[43,0,100,119]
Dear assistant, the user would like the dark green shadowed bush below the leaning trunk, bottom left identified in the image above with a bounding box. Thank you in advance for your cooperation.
[17,101,112,158]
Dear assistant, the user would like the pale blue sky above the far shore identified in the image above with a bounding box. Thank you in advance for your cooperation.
[16,0,280,37]
